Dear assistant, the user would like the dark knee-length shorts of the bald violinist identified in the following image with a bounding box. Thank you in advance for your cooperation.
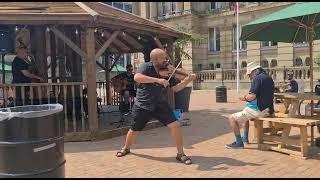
[131,105,177,131]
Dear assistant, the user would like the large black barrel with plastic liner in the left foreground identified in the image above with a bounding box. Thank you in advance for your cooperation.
[0,104,66,178]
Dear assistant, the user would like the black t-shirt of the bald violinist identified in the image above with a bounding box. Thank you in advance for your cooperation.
[135,62,177,111]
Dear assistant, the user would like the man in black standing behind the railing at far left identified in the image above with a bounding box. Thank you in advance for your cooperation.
[12,42,42,106]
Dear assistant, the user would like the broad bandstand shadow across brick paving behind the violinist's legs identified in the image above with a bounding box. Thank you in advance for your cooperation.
[65,108,240,153]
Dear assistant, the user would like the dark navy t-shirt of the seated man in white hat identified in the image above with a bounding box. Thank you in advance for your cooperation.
[250,73,274,114]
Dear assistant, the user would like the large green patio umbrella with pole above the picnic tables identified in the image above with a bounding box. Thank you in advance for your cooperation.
[240,2,320,92]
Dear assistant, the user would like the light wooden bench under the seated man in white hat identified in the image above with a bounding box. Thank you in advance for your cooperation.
[253,117,320,158]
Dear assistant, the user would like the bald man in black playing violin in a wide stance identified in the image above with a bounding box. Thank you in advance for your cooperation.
[116,49,196,165]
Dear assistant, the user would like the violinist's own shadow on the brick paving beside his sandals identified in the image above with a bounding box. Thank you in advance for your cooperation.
[131,153,264,171]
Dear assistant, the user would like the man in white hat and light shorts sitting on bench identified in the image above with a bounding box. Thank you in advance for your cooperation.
[226,62,274,148]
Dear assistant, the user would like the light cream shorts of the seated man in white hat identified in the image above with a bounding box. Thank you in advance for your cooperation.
[231,107,264,124]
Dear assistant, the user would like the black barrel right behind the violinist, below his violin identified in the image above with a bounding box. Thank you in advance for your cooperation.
[175,87,192,112]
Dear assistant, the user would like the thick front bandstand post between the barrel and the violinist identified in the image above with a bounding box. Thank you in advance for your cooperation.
[86,27,98,131]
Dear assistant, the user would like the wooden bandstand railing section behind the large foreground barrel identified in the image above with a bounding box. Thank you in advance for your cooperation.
[0,82,89,132]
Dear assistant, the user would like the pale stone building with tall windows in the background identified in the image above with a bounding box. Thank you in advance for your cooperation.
[127,2,320,89]
